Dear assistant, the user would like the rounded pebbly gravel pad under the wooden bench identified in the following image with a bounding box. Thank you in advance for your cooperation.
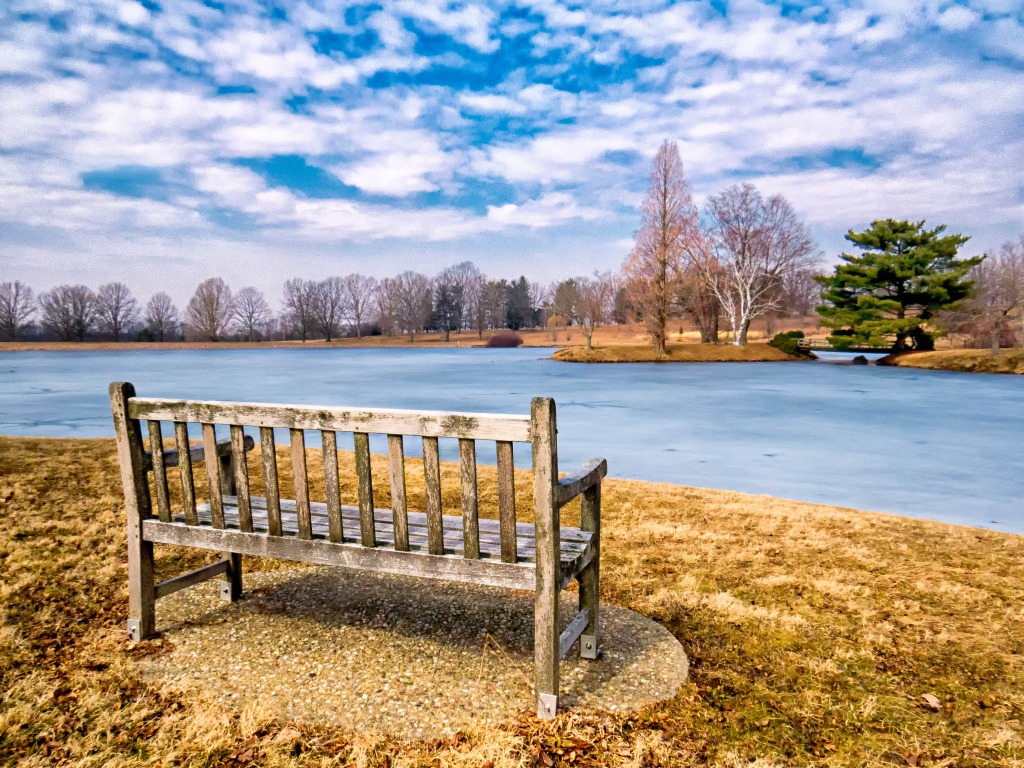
[140,567,688,739]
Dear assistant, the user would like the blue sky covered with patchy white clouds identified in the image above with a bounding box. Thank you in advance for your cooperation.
[0,0,1024,305]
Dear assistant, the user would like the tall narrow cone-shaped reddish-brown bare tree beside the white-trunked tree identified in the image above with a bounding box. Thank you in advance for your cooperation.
[625,141,702,355]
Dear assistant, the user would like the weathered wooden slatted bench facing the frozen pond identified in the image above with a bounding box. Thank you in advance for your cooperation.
[110,382,607,718]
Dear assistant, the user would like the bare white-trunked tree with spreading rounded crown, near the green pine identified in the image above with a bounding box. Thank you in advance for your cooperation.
[702,184,816,346]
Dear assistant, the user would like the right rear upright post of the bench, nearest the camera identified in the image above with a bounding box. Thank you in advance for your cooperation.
[530,397,561,719]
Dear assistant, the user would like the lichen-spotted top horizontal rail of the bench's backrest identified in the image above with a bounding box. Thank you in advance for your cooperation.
[129,397,530,442]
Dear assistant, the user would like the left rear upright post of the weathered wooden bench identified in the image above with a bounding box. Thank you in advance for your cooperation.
[110,382,154,641]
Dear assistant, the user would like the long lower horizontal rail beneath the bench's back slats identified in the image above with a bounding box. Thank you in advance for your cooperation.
[143,519,534,590]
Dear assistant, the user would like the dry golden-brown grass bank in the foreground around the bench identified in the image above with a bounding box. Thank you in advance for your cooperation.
[0,437,1024,768]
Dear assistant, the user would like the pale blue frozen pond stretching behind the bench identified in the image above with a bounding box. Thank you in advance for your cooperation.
[0,349,1024,532]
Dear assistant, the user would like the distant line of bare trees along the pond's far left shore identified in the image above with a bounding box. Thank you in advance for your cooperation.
[0,268,628,343]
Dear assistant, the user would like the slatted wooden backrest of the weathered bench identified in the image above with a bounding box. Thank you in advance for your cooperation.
[111,383,559,562]
